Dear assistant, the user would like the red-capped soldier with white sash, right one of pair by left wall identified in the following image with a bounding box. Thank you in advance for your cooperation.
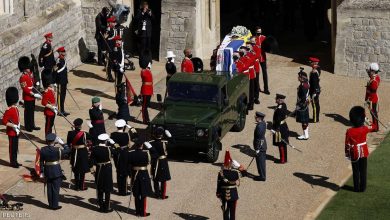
[56,47,69,116]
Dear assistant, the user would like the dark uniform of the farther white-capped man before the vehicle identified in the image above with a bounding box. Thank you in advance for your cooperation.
[110,131,130,196]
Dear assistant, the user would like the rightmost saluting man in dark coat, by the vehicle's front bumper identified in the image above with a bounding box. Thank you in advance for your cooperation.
[149,127,172,199]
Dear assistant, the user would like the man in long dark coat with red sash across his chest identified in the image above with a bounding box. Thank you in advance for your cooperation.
[66,118,92,191]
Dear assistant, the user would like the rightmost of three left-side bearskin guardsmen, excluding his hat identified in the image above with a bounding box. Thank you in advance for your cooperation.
[42,82,58,136]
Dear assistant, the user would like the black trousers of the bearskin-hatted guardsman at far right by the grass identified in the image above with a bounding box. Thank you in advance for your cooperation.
[352,158,367,192]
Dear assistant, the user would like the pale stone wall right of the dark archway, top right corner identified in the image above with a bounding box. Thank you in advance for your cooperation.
[335,0,390,80]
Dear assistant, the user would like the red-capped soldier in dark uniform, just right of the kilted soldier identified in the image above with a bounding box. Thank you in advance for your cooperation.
[309,57,321,123]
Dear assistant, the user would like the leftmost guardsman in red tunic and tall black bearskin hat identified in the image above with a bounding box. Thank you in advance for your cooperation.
[2,87,21,168]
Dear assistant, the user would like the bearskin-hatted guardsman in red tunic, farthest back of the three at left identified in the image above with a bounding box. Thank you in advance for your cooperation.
[18,56,42,132]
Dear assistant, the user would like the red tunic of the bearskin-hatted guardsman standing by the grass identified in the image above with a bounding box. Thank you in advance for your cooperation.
[345,126,372,161]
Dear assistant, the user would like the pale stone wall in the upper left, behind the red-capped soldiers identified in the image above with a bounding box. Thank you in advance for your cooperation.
[0,0,86,106]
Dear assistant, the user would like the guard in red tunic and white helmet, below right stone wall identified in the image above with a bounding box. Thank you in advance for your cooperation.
[365,63,381,131]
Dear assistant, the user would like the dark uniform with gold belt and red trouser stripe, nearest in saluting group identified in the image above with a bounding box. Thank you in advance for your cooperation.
[128,148,152,216]
